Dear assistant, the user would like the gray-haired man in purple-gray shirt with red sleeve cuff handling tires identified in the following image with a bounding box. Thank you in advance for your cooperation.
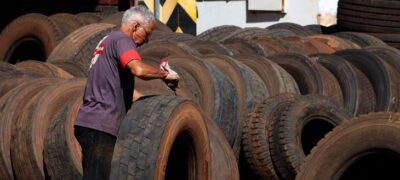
[75,6,179,180]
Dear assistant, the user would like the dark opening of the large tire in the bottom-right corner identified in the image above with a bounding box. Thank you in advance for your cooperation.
[339,149,400,180]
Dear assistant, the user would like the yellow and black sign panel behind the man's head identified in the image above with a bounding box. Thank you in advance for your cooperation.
[144,0,197,35]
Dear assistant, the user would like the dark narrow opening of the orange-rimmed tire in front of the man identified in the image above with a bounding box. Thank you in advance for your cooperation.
[165,132,197,180]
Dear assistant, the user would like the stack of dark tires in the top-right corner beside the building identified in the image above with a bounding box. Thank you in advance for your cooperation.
[337,0,400,48]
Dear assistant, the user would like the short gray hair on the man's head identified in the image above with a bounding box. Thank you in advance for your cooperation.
[122,5,154,27]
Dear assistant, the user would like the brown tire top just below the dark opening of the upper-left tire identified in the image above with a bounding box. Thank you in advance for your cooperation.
[15,60,74,79]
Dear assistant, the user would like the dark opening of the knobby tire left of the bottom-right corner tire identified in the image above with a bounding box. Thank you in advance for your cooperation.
[301,117,335,156]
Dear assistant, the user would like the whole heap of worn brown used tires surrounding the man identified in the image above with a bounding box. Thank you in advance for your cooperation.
[0,12,400,180]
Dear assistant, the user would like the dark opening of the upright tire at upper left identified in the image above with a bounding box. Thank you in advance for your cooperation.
[5,37,47,64]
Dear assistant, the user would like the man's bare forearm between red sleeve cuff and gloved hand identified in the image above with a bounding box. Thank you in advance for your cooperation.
[125,60,168,80]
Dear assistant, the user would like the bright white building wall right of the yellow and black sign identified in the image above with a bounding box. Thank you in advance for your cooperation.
[197,0,322,34]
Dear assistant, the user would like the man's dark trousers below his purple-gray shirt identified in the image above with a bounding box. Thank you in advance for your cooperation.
[74,126,117,180]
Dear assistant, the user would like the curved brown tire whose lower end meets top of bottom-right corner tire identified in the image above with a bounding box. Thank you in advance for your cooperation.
[311,54,376,116]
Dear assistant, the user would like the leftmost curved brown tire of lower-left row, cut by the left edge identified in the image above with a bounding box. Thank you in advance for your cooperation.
[0,78,55,179]
